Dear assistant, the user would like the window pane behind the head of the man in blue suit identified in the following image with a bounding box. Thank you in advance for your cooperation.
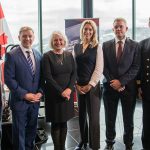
[1,0,38,44]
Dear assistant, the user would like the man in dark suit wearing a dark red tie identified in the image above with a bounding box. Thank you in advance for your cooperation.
[103,18,140,150]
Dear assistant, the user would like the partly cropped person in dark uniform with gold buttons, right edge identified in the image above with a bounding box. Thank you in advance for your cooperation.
[140,18,150,150]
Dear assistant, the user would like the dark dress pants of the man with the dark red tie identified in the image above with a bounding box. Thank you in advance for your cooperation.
[103,84,136,147]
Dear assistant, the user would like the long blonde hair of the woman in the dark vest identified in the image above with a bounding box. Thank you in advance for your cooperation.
[80,20,98,47]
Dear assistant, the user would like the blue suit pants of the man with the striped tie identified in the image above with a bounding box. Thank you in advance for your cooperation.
[12,101,39,150]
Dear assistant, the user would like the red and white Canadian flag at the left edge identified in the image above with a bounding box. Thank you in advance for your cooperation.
[0,3,14,85]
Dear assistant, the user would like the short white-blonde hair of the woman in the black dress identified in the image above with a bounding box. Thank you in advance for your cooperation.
[49,31,68,49]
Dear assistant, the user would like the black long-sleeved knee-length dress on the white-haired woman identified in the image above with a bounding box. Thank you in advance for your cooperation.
[42,51,76,123]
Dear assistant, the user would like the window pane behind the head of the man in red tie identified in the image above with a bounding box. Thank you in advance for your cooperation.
[93,0,132,42]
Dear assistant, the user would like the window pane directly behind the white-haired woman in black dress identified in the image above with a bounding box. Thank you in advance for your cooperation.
[42,0,81,51]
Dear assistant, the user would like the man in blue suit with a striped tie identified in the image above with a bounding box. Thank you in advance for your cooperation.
[4,26,42,150]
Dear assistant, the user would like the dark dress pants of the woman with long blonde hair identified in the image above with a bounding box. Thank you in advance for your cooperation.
[78,84,101,149]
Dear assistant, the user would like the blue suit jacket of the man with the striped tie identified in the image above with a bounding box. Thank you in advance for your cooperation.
[4,46,41,108]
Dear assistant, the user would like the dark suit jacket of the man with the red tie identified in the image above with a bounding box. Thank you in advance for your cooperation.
[103,38,140,86]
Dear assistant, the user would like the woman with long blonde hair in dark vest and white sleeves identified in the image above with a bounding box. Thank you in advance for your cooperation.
[73,20,103,150]
